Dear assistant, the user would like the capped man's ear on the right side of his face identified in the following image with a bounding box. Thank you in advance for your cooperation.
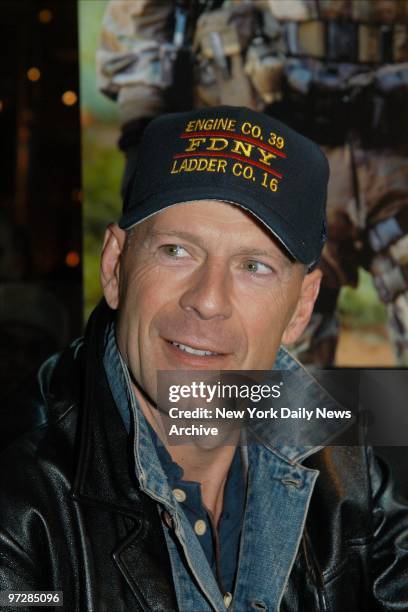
[282,269,322,344]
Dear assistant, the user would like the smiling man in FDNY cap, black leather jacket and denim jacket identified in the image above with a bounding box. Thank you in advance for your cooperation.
[0,107,408,612]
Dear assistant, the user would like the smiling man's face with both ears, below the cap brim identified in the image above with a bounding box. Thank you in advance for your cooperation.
[102,200,320,406]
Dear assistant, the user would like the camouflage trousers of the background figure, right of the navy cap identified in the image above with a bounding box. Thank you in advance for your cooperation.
[292,144,408,366]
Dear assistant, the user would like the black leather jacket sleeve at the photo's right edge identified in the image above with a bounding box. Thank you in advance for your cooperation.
[368,449,408,610]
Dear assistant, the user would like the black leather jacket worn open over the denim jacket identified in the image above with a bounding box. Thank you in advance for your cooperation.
[0,304,408,612]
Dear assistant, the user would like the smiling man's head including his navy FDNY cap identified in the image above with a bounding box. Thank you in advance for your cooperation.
[101,108,327,398]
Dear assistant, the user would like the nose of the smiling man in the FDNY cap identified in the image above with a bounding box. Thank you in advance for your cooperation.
[180,261,232,319]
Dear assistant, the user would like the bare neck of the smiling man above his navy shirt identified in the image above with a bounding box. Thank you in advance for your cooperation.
[134,387,238,525]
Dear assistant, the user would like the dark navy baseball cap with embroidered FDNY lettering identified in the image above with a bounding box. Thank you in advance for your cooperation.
[119,106,329,266]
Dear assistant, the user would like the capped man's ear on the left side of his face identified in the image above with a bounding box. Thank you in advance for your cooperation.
[100,223,126,310]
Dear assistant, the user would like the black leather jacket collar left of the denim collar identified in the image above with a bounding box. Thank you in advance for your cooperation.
[73,301,147,516]
